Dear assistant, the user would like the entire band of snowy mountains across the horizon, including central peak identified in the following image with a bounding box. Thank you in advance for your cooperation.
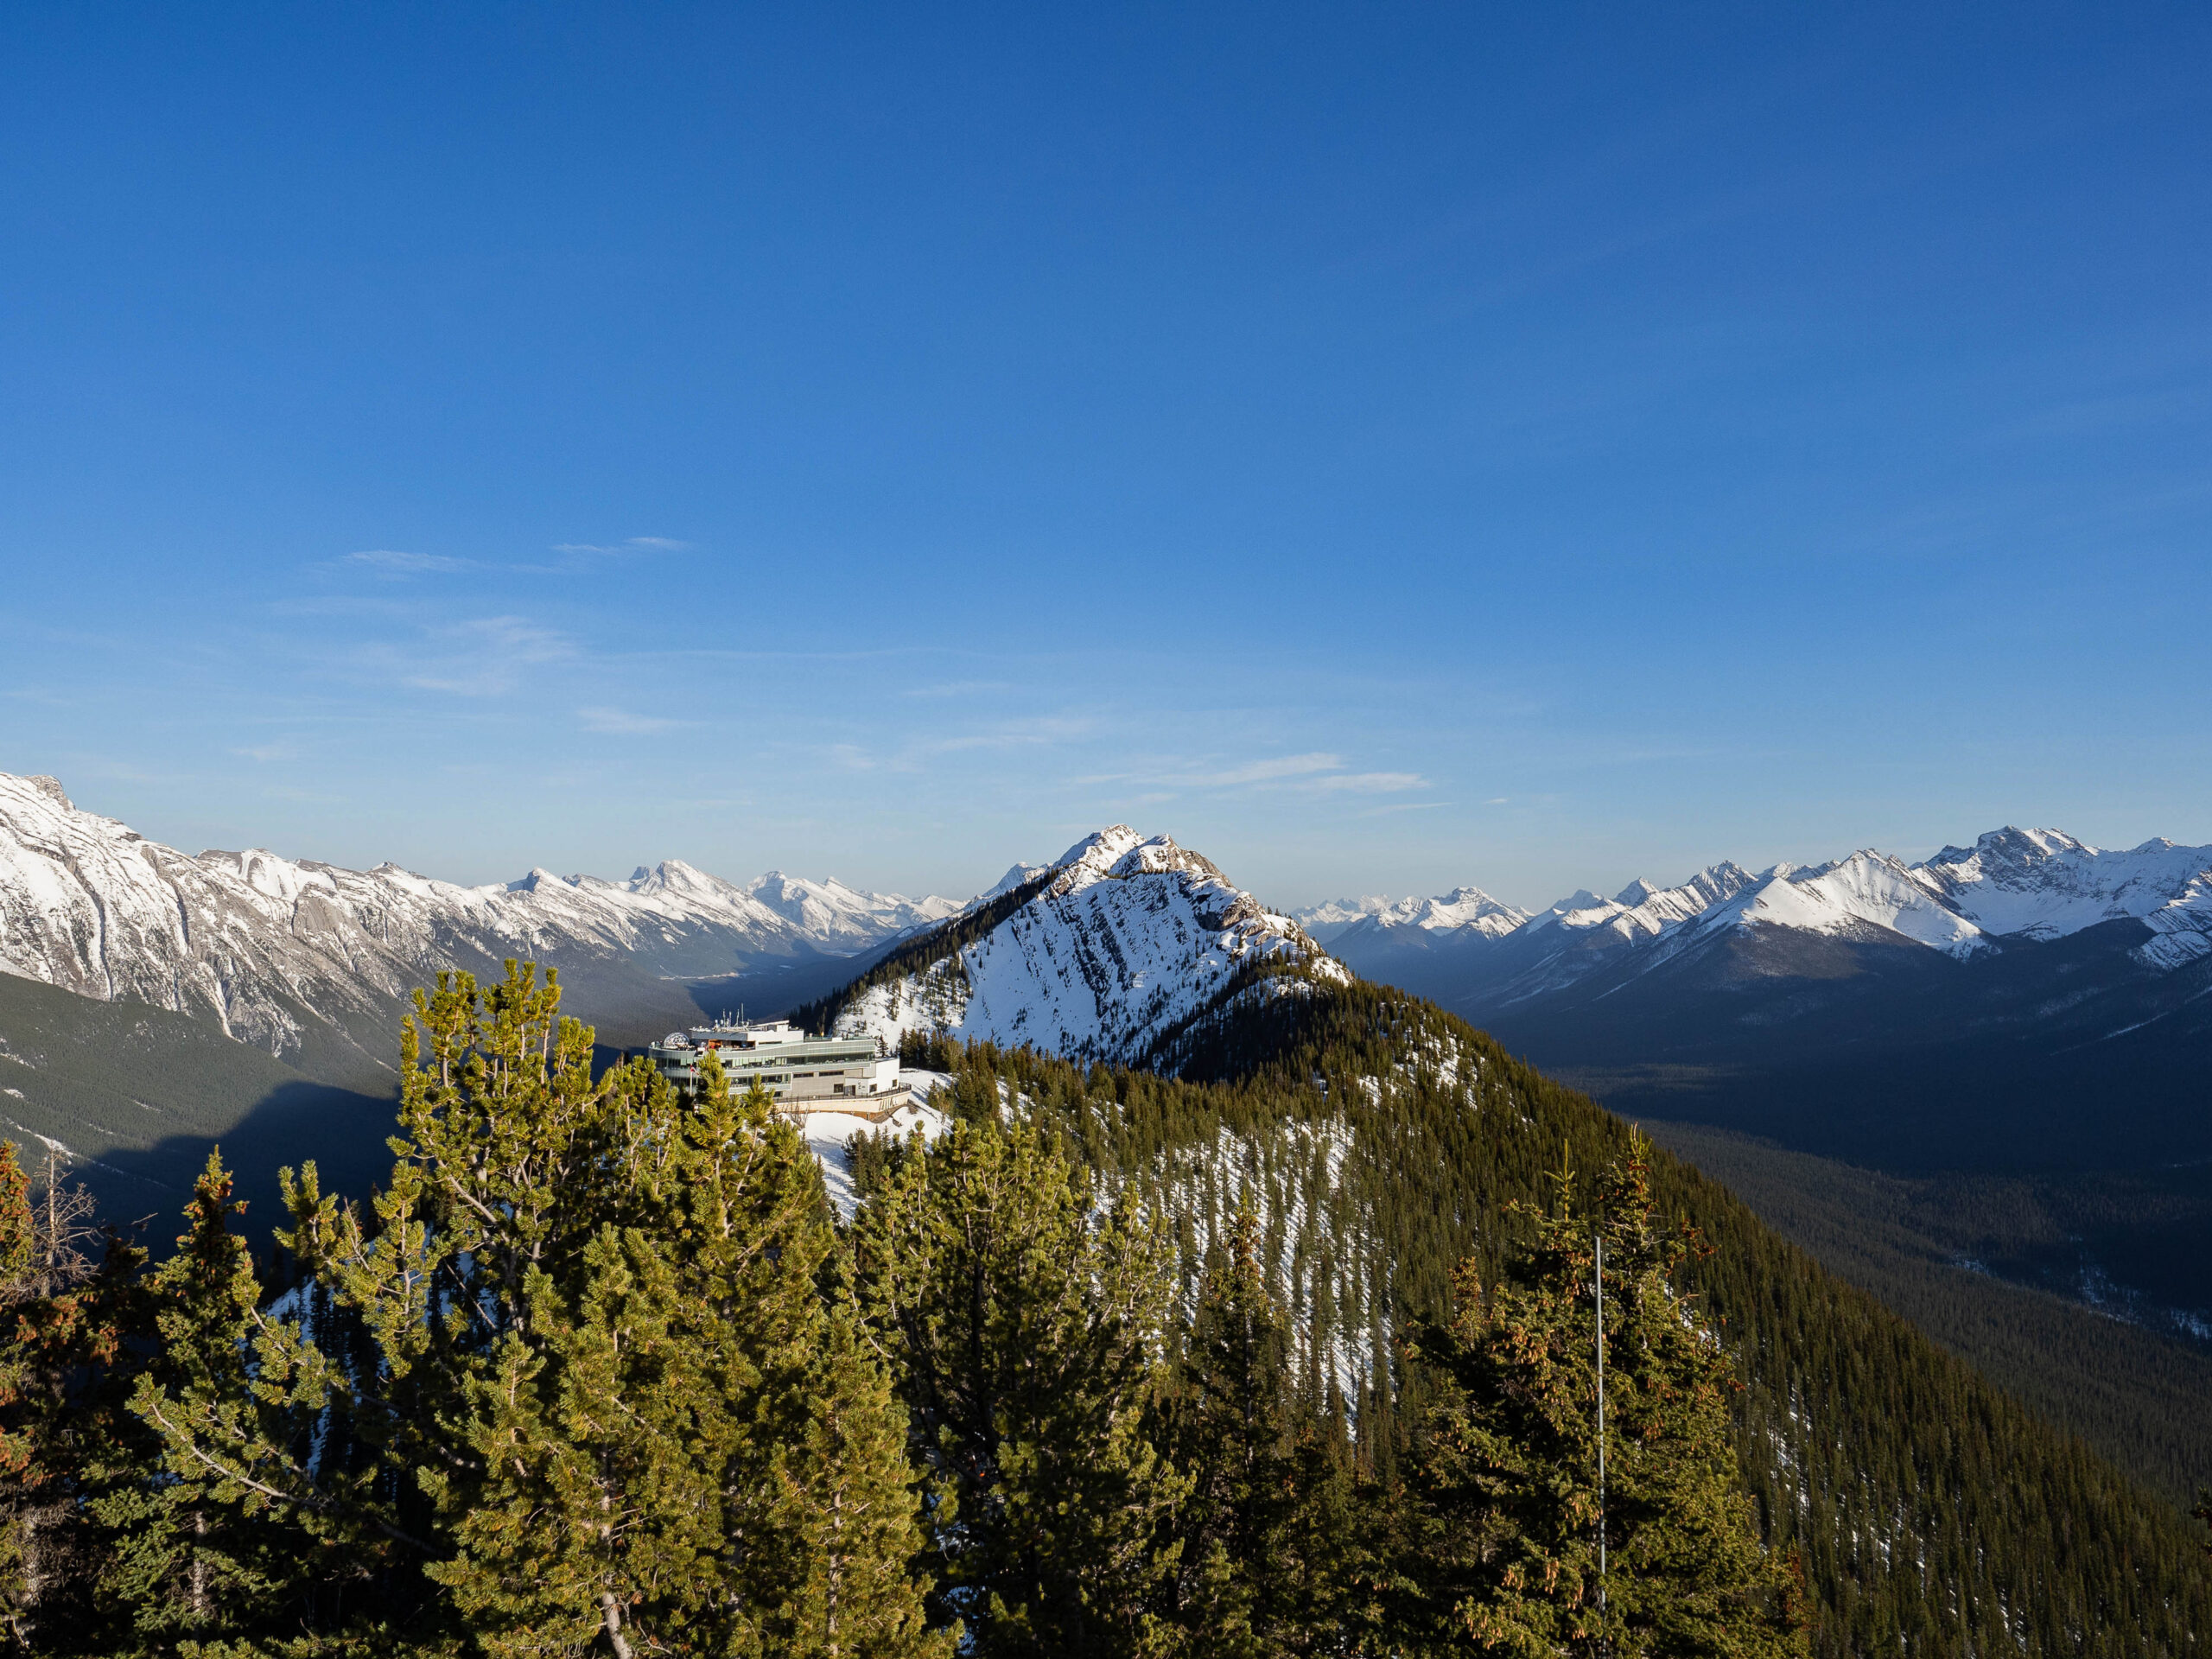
[0,774,2212,1305]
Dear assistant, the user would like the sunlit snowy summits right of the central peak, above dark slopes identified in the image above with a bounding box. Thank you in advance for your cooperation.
[1300,827,2212,1007]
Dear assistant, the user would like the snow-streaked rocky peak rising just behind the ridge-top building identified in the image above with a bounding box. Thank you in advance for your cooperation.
[836,825,1350,1062]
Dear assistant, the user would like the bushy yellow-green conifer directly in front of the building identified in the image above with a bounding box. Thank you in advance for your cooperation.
[431,1039,949,1659]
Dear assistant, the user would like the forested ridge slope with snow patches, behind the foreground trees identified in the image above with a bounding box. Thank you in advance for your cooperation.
[885,978,2212,1655]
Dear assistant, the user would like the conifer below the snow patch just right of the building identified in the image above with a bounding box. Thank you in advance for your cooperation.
[852,1115,1185,1659]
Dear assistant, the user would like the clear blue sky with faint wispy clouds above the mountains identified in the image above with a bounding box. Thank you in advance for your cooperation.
[0,4,2212,902]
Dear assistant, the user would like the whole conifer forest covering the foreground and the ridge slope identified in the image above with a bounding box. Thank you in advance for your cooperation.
[0,969,2212,1659]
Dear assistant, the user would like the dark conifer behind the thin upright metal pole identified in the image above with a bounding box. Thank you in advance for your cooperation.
[1405,1139,1802,1659]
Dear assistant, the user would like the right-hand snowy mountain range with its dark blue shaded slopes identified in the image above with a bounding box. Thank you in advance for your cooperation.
[1299,827,2212,1170]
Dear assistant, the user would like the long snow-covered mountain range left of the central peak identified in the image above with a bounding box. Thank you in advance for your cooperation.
[0,774,957,1071]
